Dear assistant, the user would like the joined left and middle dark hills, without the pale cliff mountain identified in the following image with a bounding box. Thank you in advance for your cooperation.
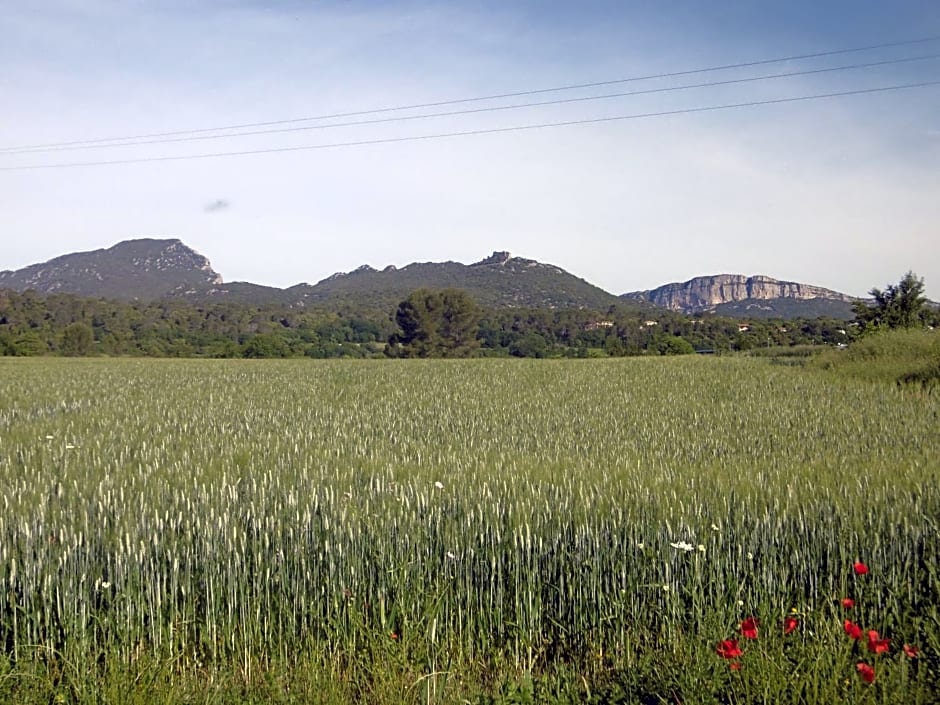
[0,239,623,310]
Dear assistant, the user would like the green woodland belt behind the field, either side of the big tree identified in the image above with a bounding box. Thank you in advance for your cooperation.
[0,290,872,358]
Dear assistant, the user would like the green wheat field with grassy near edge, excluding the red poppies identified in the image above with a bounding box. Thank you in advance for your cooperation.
[0,358,940,703]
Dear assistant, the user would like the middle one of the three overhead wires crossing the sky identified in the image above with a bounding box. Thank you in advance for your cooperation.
[0,54,940,155]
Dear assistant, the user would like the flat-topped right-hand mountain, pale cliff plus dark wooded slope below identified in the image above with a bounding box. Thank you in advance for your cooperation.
[621,274,856,319]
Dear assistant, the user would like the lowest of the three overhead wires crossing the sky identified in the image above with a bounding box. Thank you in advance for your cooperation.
[0,81,940,171]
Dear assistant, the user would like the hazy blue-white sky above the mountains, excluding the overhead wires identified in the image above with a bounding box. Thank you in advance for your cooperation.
[0,0,940,299]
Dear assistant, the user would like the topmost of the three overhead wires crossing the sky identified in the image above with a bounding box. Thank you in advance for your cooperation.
[0,35,940,152]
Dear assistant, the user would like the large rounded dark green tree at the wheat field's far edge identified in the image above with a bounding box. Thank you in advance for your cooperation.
[389,289,480,357]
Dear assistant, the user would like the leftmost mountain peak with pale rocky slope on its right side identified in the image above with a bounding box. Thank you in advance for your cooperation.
[0,239,222,301]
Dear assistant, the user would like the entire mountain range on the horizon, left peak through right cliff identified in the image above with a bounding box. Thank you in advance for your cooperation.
[0,238,857,318]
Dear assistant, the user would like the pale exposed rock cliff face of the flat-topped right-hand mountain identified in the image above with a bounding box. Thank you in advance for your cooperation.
[621,274,855,313]
